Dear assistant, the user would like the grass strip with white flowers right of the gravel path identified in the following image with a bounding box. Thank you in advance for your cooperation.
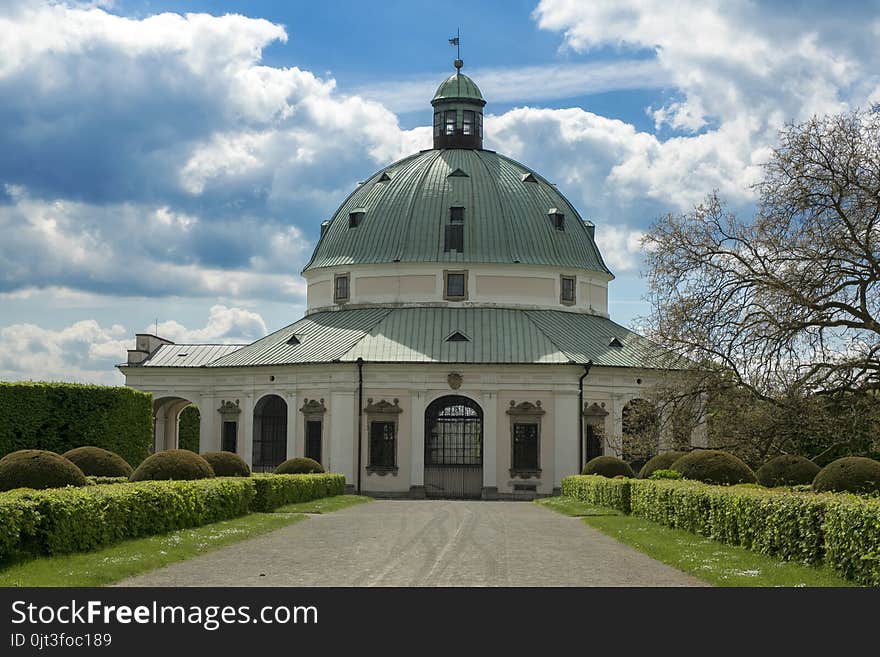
[539,497,856,586]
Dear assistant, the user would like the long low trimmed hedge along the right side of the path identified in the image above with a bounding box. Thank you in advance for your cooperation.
[562,475,880,586]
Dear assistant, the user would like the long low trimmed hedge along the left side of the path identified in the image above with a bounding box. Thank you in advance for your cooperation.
[0,478,256,561]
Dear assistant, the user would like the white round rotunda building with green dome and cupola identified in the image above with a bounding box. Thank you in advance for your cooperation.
[120,60,696,499]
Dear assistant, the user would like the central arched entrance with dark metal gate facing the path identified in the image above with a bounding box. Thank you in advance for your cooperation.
[425,395,483,498]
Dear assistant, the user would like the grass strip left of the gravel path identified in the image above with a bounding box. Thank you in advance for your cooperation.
[0,513,306,586]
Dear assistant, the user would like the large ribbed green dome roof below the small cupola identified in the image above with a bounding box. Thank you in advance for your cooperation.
[305,148,610,274]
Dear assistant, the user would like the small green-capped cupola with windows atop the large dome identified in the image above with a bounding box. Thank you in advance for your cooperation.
[431,59,486,148]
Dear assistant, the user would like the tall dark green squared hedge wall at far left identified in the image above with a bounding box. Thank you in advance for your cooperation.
[0,382,153,465]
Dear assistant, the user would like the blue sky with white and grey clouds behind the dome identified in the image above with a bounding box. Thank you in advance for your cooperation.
[0,0,880,383]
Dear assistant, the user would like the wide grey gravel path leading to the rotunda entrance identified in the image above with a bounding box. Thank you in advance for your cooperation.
[119,500,706,586]
